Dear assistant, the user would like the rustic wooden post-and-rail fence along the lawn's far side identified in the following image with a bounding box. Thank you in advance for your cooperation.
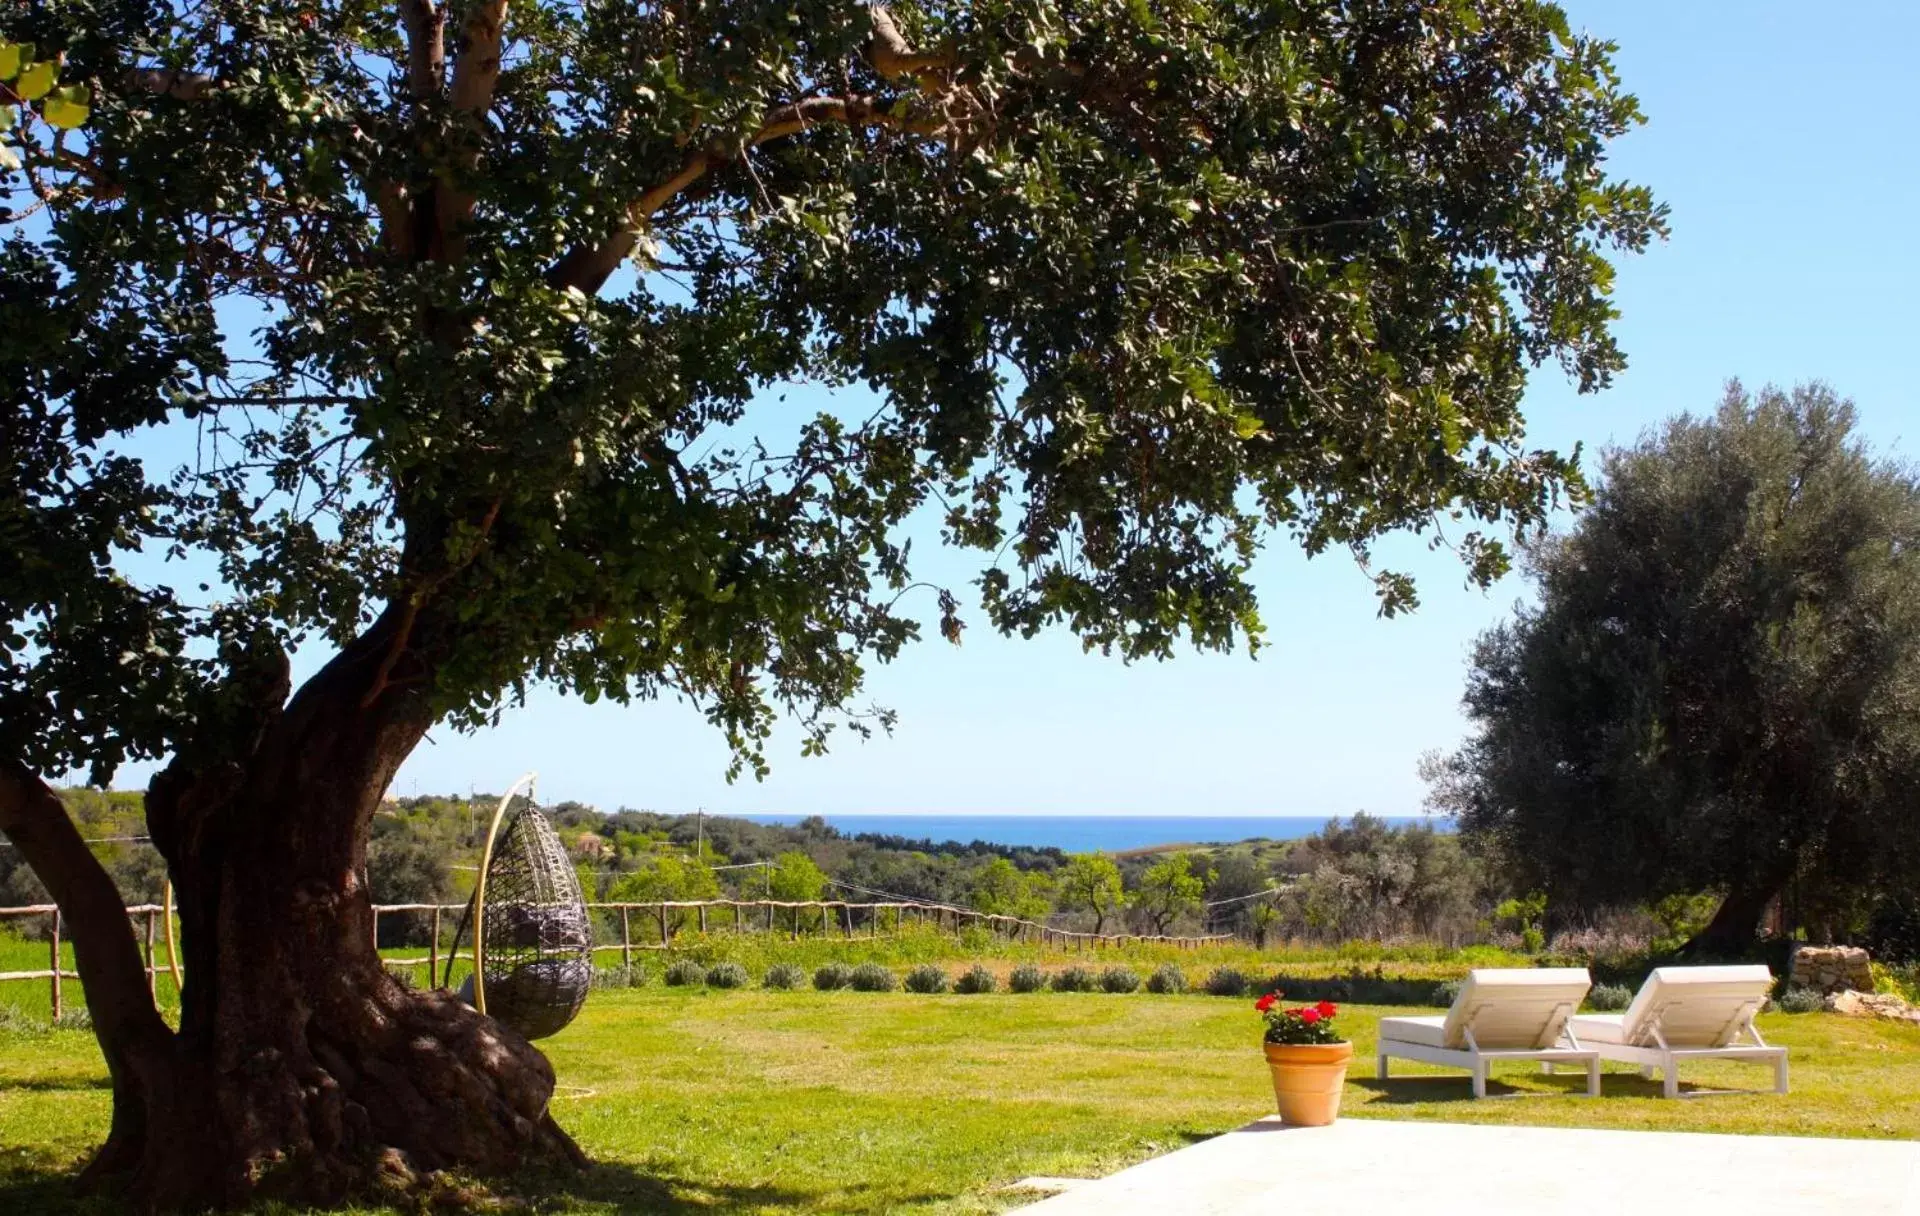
[0,899,1233,1020]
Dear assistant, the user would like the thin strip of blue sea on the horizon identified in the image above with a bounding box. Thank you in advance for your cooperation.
[739,815,1452,853]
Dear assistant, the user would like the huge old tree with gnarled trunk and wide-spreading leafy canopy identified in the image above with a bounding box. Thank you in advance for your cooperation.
[0,0,1663,1204]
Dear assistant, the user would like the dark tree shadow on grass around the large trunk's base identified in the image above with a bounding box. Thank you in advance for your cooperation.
[0,1156,954,1216]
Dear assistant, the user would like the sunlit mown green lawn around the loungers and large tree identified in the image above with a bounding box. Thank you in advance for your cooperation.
[0,989,1920,1212]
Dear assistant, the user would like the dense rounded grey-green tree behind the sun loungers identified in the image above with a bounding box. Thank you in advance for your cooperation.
[1428,384,1920,953]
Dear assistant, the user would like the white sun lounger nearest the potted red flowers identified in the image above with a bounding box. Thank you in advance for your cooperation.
[1379,966,1599,1097]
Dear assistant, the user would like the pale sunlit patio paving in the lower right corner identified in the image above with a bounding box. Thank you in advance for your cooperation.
[1023,1118,1920,1216]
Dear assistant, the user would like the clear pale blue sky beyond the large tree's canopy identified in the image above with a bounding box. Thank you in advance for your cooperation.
[127,0,1920,815]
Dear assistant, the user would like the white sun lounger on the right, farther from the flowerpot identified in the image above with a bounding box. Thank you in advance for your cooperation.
[1571,964,1788,1097]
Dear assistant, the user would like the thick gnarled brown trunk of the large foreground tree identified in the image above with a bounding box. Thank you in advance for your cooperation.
[0,611,582,1208]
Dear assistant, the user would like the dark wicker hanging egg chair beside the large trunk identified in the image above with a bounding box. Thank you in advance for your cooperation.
[447,774,593,1039]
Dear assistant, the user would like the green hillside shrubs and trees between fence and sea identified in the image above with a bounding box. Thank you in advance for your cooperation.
[0,790,1497,945]
